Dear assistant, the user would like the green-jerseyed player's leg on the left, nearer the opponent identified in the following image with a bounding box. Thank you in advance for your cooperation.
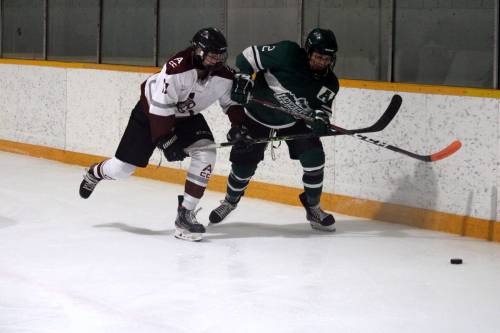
[209,117,270,223]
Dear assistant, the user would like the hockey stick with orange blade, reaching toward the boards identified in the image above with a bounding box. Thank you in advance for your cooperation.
[252,98,462,162]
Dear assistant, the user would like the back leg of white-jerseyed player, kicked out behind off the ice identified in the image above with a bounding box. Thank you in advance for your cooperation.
[80,101,155,199]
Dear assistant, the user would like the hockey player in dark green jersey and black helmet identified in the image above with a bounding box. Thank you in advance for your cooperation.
[209,28,339,231]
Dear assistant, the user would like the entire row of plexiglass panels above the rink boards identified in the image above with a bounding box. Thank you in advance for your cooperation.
[1,0,499,88]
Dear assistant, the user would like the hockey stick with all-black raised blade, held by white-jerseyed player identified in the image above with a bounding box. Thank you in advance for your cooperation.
[184,95,402,153]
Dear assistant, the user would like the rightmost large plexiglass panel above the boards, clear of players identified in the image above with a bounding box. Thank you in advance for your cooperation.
[394,0,494,88]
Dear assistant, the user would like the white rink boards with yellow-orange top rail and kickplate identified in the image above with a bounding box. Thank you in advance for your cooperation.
[0,59,500,241]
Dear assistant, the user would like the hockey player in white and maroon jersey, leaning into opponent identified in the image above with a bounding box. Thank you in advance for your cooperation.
[80,28,241,241]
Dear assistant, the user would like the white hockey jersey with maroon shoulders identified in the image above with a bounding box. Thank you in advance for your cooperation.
[144,48,238,118]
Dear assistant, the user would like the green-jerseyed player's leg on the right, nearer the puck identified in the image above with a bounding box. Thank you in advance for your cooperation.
[286,124,335,231]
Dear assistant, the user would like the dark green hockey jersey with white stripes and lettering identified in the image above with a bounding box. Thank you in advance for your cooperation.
[236,41,339,128]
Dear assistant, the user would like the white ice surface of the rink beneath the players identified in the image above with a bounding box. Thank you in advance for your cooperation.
[0,153,500,333]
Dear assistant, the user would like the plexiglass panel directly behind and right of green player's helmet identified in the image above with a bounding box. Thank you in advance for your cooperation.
[303,0,391,81]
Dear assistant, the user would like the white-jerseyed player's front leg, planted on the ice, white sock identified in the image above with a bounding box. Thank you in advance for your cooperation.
[171,114,216,241]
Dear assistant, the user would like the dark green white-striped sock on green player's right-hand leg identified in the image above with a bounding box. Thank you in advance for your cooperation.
[300,148,325,207]
